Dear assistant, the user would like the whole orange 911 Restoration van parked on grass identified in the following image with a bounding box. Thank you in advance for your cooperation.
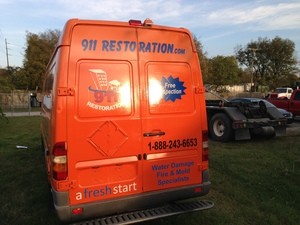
[41,19,213,222]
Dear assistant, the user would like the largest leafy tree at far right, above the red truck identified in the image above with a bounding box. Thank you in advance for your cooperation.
[236,37,297,90]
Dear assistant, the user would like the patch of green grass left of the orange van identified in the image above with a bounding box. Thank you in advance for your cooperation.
[0,117,59,225]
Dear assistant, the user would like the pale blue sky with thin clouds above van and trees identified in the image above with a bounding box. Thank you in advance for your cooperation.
[0,0,300,68]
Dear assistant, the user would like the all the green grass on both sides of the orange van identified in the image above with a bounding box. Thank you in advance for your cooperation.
[0,117,300,225]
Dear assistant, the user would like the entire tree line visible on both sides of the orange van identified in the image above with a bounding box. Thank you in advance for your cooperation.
[0,30,299,92]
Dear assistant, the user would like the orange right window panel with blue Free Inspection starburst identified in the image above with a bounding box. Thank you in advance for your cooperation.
[147,62,195,114]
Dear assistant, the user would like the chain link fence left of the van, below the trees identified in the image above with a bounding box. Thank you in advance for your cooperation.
[0,90,41,117]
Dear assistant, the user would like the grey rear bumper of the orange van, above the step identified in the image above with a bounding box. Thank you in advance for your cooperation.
[52,181,210,222]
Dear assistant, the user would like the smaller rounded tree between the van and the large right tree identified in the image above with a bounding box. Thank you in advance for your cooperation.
[207,56,242,90]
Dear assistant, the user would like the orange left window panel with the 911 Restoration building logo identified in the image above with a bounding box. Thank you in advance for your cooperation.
[77,60,132,118]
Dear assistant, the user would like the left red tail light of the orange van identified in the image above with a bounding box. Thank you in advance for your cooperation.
[52,142,68,180]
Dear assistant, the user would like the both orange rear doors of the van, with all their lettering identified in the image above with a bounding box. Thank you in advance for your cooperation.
[63,21,206,205]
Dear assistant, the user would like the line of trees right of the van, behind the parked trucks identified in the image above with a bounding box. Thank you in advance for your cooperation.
[194,36,300,91]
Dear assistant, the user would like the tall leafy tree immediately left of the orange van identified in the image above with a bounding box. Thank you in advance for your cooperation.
[18,30,60,90]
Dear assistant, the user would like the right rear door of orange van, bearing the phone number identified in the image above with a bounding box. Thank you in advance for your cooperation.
[138,28,206,191]
